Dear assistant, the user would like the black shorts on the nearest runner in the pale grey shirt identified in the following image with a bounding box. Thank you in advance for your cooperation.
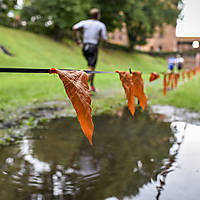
[83,43,98,67]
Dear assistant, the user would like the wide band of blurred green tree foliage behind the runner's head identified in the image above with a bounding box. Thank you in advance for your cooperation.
[21,0,182,45]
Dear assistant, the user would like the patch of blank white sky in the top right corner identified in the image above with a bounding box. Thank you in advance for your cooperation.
[176,0,200,37]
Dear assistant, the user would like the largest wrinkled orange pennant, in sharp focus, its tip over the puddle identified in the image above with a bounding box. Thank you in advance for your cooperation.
[50,68,94,144]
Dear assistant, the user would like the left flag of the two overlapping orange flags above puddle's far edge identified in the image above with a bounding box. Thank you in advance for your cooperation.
[116,71,135,115]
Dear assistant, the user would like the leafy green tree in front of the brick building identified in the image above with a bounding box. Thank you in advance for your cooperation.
[123,0,182,49]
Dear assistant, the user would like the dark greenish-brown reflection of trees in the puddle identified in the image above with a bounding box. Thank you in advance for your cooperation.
[0,107,172,200]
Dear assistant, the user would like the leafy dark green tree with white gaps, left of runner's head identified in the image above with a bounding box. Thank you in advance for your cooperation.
[21,0,86,39]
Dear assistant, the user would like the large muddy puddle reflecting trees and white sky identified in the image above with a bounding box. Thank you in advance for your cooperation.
[0,109,200,200]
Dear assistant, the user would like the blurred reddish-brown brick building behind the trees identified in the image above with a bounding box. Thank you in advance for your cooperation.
[108,23,200,52]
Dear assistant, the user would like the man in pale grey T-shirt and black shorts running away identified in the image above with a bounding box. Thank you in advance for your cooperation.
[72,8,107,92]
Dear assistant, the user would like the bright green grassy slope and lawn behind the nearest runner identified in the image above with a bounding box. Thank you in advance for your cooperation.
[0,26,166,111]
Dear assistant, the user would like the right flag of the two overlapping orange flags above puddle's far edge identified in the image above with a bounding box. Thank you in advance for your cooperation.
[131,72,147,110]
